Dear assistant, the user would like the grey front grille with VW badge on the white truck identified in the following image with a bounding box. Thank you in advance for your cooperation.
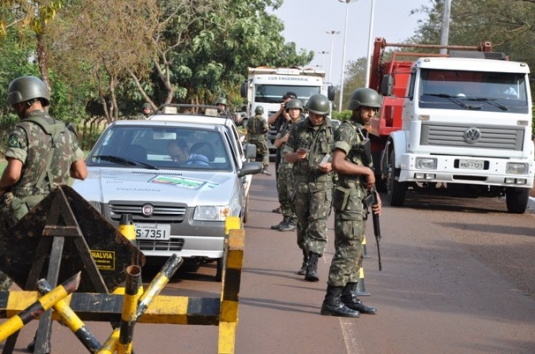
[420,123,524,151]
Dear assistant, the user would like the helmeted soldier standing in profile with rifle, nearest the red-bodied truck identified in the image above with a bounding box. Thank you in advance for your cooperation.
[321,88,381,317]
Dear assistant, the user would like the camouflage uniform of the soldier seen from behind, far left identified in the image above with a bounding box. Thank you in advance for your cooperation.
[0,111,84,290]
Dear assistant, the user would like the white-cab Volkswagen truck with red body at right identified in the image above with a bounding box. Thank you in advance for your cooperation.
[371,47,535,214]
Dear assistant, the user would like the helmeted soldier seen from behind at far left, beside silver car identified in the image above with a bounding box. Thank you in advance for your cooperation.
[0,76,87,290]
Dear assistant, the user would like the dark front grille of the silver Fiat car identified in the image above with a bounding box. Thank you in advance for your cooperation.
[108,200,187,223]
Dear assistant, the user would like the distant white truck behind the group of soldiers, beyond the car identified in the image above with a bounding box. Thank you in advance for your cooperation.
[241,66,334,160]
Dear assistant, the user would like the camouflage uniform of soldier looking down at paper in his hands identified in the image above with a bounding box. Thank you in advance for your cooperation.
[282,117,333,257]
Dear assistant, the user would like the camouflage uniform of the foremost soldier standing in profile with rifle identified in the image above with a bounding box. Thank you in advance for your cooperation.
[327,121,371,287]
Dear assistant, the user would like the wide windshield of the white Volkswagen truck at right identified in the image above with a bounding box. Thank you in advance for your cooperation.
[417,69,528,113]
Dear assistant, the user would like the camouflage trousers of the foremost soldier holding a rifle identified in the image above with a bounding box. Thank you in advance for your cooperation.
[327,212,366,287]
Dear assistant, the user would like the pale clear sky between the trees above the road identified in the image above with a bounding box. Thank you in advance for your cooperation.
[273,0,430,85]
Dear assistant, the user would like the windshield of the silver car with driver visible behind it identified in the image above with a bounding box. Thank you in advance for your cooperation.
[86,124,231,170]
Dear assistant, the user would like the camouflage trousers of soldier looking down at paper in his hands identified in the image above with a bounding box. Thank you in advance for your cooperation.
[294,186,332,256]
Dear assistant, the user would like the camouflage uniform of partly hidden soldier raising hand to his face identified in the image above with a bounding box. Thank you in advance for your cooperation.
[275,114,305,220]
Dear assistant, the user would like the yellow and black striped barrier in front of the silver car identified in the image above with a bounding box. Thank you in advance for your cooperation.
[0,218,245,354]
